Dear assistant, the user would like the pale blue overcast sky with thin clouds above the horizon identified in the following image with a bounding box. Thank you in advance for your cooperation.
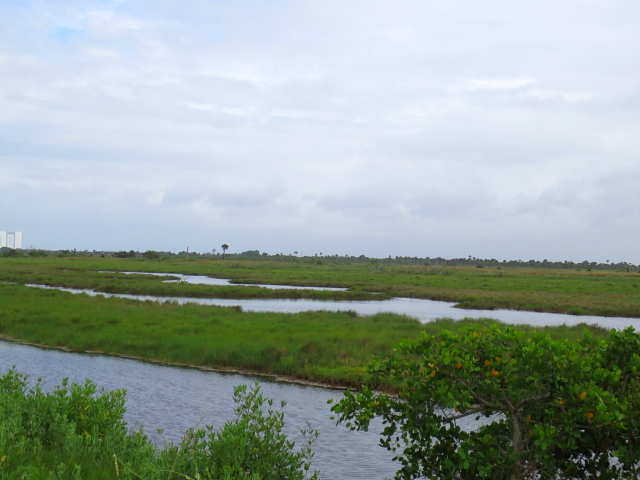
[0,0,640,264]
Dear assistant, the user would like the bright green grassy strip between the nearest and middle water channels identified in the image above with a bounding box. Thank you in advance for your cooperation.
[0,284,606,386]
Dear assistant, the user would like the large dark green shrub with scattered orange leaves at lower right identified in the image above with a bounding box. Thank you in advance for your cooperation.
[332,326,640,480]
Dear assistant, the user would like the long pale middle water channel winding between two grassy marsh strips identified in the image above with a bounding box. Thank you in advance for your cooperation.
[31,285,640,330]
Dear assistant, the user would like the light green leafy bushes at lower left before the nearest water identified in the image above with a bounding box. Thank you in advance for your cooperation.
[0,369,318,480]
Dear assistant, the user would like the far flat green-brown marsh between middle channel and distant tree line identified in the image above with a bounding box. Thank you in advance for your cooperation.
[0,257,640,317]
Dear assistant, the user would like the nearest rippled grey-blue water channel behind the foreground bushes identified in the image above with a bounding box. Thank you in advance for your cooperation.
[0,341,399,480]
